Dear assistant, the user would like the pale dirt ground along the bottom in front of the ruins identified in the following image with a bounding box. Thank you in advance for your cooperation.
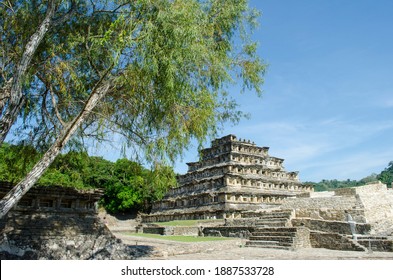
[116,232,393,260]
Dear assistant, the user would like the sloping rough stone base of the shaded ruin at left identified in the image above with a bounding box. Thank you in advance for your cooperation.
[0,212,134,260]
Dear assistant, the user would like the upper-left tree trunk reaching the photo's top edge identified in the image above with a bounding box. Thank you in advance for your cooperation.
[0,0,56,145]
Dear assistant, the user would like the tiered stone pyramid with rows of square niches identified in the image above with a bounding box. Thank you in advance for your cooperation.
[143,135,313,222]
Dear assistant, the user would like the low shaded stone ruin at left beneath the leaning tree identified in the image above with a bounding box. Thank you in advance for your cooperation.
[0,182,141,260]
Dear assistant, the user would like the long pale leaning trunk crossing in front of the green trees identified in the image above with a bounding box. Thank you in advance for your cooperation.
[0,82,111,219]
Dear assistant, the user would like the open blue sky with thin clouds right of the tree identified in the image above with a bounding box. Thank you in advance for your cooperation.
[175,0,393,181]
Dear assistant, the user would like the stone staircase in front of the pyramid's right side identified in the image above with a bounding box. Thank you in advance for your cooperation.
[246,210,297,250]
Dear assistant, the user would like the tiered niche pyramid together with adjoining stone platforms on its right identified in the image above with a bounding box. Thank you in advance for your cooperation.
[141,135,393,252]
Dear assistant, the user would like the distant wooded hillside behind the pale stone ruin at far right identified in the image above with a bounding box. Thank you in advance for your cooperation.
[305,161,393,191]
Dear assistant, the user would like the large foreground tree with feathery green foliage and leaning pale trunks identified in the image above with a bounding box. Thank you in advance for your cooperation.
[0,0,265,217]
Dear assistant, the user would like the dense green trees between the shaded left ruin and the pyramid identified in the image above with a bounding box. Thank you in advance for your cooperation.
[0,143,176,213]
